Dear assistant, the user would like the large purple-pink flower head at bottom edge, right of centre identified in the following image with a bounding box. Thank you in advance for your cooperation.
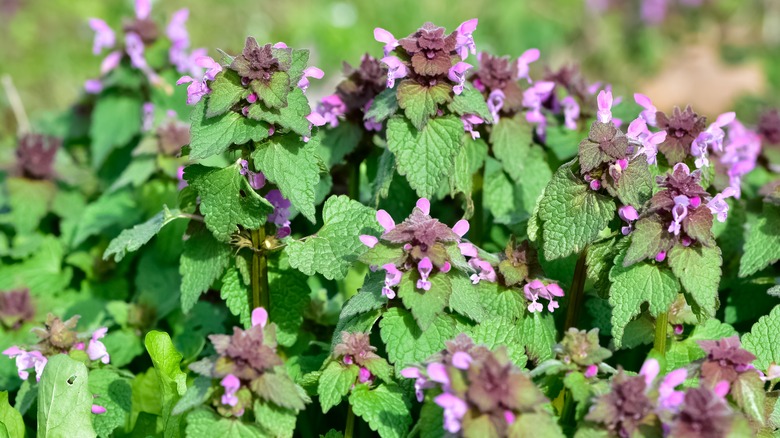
[401,334,547,436]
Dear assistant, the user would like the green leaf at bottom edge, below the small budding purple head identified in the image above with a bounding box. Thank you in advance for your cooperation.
[349,384,412,438]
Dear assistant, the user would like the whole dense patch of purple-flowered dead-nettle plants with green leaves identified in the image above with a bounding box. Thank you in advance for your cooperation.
[0,0,780,438]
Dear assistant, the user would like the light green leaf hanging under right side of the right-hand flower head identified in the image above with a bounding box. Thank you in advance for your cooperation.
[667,245,723,317]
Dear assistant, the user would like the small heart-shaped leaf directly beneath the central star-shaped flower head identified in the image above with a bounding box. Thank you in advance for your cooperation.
[398,271,452,331]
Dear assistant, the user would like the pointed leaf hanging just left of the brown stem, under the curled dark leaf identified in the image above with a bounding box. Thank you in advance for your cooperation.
[179,227,233,313]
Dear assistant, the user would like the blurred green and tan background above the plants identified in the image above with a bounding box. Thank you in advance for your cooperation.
[0,0,780,133]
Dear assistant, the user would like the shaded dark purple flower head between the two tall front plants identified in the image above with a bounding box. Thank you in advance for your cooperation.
[316,54,387,131]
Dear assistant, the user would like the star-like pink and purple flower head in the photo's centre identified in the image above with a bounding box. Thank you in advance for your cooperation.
[360,198,469,299]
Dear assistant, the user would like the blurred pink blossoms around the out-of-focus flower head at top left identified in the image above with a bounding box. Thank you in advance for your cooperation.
[84,0,206,94]
